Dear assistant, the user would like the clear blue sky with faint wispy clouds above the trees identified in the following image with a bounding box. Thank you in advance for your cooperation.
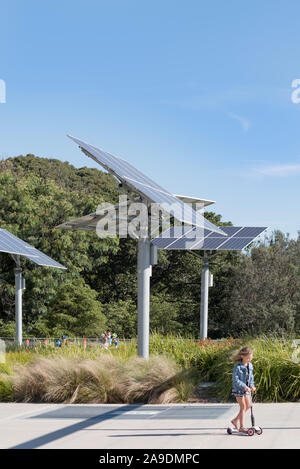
[0,0,300,237]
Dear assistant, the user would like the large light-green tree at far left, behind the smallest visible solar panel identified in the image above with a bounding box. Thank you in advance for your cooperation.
[0,155,118,333]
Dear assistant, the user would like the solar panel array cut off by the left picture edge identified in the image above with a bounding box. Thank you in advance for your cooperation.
[0,229,66,269]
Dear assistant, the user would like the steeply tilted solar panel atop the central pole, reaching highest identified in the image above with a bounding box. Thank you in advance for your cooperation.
[68,135,224,235]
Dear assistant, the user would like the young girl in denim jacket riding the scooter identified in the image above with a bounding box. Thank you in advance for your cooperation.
[231,347,256,432]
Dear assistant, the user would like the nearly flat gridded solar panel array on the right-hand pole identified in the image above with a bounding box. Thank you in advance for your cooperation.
[152,226,267,251]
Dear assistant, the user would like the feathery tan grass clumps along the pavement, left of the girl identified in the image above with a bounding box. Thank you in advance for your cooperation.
[12,353,193,403]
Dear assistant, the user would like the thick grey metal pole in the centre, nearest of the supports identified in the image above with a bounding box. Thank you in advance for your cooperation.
[138,237,151,360]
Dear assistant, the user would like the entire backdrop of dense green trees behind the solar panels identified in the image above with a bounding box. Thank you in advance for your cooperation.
[0,155,300,338]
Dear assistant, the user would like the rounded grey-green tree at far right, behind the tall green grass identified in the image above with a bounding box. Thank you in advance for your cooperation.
[213,232,300,335]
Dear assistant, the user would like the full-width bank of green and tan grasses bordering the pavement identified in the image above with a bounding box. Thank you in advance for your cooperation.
[0,334,300,403]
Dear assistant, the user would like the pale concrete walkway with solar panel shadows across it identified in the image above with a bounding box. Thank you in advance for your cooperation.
[0,403,300,449]
